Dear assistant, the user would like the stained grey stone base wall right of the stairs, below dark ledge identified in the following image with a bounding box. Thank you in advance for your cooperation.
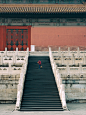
[65,83,86,100]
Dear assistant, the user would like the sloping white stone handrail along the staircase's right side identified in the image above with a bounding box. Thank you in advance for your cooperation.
[49,47,67,110]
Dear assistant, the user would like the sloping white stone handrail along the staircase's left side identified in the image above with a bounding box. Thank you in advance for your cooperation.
[15,50,29,110]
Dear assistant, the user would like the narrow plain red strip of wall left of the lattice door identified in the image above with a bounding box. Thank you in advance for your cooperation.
[0,26,6,51]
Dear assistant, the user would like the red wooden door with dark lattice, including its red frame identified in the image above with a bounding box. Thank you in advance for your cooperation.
[6,26,31,51]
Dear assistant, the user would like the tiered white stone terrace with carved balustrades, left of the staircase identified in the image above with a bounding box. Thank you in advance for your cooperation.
[0,48,29,103]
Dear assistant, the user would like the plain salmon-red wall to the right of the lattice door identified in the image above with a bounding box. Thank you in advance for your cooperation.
[31,27,86,47]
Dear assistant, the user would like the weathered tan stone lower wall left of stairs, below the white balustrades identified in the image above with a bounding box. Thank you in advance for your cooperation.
[0,75,20,103]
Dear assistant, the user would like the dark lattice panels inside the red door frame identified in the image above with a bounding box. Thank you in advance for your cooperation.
[6,29,28,51]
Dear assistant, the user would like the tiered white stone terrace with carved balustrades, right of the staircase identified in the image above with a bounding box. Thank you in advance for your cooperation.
[53,48,86,102]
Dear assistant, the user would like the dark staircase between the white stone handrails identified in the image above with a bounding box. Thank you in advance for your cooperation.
[20,56,63,111]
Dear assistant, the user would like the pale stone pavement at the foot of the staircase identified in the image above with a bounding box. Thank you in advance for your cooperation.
[0,103,86,115]
